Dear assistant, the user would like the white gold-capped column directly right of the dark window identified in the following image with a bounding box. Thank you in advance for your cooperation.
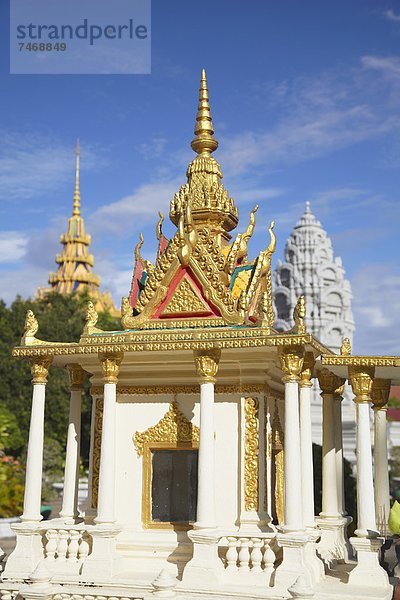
[194,350,220,529]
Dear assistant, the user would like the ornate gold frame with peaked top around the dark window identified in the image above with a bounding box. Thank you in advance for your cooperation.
[133,401,200,531]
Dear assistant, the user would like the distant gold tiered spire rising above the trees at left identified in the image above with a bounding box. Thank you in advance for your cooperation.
[37,140,118,316]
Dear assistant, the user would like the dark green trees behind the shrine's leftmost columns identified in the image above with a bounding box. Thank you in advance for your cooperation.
[0,293,118,476]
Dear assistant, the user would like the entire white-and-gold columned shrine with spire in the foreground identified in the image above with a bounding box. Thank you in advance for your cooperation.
[0,72,400,600]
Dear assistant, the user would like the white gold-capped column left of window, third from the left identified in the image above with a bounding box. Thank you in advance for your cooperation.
[94,355,121,524]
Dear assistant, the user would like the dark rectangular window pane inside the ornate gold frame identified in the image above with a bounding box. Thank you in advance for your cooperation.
[151,450,197,523]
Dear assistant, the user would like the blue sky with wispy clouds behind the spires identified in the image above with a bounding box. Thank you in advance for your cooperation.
[0,0,400,354]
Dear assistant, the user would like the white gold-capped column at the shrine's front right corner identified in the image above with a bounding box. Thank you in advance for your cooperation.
[280,344,304,532]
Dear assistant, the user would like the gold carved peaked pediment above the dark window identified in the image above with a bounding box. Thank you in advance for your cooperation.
[133,402,200,456]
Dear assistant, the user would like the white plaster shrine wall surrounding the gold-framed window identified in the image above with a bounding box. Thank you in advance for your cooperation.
[116,394,238,535]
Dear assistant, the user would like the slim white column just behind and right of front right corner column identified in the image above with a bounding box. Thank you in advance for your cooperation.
[300,352,315,527]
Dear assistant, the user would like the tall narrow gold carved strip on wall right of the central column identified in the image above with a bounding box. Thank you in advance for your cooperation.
[244,398,259,511]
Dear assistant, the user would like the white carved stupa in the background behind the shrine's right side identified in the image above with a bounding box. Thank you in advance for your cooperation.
[273,202,356,464]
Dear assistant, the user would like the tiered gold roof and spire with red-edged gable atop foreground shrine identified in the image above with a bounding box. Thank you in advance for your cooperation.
[122,70,276,330]
